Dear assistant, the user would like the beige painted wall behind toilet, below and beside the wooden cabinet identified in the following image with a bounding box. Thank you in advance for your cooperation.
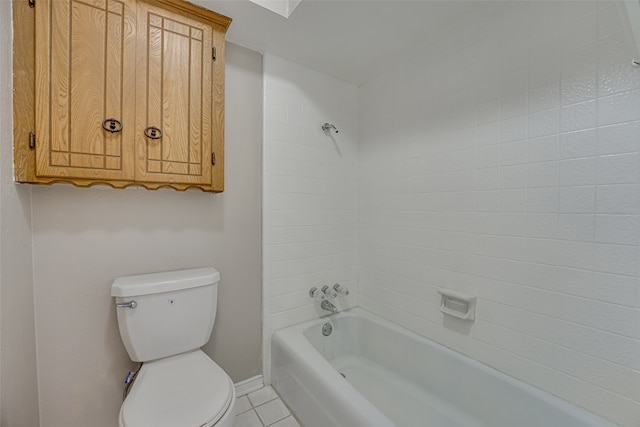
[32,44,262,427]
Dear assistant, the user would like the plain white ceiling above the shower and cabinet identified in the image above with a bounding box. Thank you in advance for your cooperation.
[192,0,487,86]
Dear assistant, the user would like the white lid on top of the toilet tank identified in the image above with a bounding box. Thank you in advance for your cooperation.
[111,267,220,297]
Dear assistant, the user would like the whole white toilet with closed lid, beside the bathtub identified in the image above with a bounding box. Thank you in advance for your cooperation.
[111,268,236,427]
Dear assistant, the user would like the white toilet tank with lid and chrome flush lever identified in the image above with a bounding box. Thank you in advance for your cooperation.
[111,268,220,362]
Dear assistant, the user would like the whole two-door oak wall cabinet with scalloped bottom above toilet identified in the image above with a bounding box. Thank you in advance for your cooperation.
[13,0,231,192]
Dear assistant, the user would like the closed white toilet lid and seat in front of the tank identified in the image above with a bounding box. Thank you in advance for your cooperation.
[120,350,235,427]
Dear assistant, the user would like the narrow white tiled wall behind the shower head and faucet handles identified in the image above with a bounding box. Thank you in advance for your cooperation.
[263,55,358,383]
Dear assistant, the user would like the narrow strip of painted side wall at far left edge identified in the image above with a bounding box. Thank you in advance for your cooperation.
[0,1,38,427]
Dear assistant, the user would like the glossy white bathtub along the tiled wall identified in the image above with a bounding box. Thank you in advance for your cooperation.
[272,308,612,427]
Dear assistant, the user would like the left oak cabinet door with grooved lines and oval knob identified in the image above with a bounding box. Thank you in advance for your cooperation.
[36,0,136,180]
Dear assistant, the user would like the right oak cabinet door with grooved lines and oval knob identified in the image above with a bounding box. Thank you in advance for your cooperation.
[136,2,212,185]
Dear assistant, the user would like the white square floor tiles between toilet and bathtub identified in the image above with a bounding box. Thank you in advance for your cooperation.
[233,386,301,427]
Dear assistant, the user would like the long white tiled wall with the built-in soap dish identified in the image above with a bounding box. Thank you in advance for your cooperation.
[359,1,640,426]
